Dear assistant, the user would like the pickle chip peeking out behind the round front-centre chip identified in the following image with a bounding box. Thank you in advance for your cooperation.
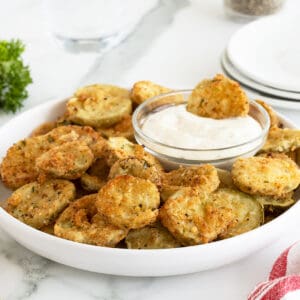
[108,157,161,187]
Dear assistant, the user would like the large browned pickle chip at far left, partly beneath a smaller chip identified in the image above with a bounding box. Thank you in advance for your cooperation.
[0,125,106,189]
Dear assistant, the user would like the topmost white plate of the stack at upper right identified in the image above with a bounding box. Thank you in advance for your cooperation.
[228,15,300,92]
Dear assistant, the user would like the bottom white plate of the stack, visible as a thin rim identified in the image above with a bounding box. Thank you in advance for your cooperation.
[221,62,300,110]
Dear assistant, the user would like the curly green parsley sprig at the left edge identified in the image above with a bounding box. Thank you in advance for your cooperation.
[0,40,32,112]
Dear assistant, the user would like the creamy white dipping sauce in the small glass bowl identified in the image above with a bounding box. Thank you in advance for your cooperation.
[142,104,262,150]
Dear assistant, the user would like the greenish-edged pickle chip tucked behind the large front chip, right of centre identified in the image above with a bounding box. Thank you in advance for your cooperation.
[214,188,264,238]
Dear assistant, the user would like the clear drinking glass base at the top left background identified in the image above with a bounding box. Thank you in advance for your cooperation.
[43,0,143,52]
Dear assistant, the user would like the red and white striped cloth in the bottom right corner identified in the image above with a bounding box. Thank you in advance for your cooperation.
[248,242,300,300]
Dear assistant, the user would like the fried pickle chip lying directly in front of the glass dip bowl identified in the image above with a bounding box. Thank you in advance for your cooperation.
[161,165,220,201]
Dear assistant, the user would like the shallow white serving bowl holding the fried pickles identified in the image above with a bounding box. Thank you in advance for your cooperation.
[0,100,300,276]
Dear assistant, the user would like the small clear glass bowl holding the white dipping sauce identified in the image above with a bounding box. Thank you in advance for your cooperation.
[132,90,270,170]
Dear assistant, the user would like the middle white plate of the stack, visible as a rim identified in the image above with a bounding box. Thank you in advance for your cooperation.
[221,50,300,101]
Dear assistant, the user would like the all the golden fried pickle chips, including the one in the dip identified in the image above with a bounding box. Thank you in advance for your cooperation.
[0,75,300,249]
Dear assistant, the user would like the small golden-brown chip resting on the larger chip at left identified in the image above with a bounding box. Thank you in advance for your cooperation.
[35,141,94,180]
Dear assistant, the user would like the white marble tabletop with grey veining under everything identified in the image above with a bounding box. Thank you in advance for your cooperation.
[0,0,300,300]
